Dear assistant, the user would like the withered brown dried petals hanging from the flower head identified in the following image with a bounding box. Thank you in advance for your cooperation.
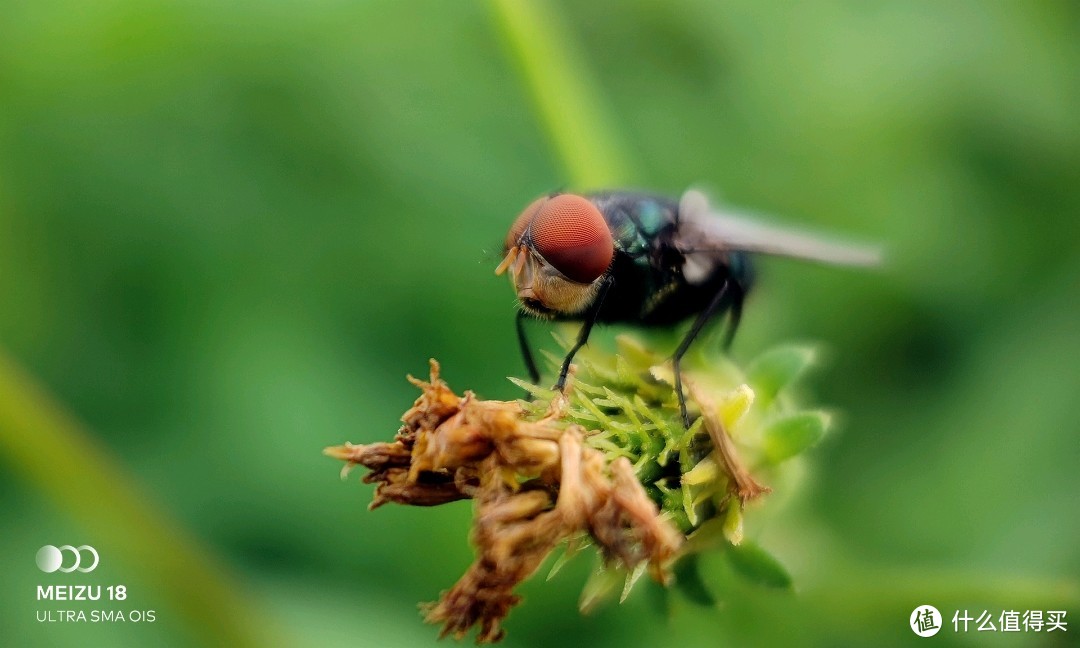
[325,360,683,643]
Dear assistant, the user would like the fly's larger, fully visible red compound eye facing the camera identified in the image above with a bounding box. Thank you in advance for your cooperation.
[529,193,615,283]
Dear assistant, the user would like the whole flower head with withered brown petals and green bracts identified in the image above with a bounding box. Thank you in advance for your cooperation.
[325,337,826,643]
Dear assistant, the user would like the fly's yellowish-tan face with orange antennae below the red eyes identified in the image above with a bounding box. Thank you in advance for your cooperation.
[510,245,603,319]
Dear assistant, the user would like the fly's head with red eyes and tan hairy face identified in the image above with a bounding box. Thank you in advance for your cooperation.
[495,193,615,319]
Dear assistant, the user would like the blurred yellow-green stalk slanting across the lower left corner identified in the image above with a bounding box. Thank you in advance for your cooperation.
[0,350,281,646]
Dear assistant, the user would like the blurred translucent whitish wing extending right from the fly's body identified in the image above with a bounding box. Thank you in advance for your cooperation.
[676,189,881,266]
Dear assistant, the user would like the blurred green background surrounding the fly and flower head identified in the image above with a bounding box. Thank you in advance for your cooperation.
[0,0,1080,647]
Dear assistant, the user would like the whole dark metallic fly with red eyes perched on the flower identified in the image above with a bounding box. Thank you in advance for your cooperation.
[496,190,879,427]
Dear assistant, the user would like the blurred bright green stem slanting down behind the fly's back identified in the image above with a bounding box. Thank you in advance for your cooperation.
[491,0,634,189]
